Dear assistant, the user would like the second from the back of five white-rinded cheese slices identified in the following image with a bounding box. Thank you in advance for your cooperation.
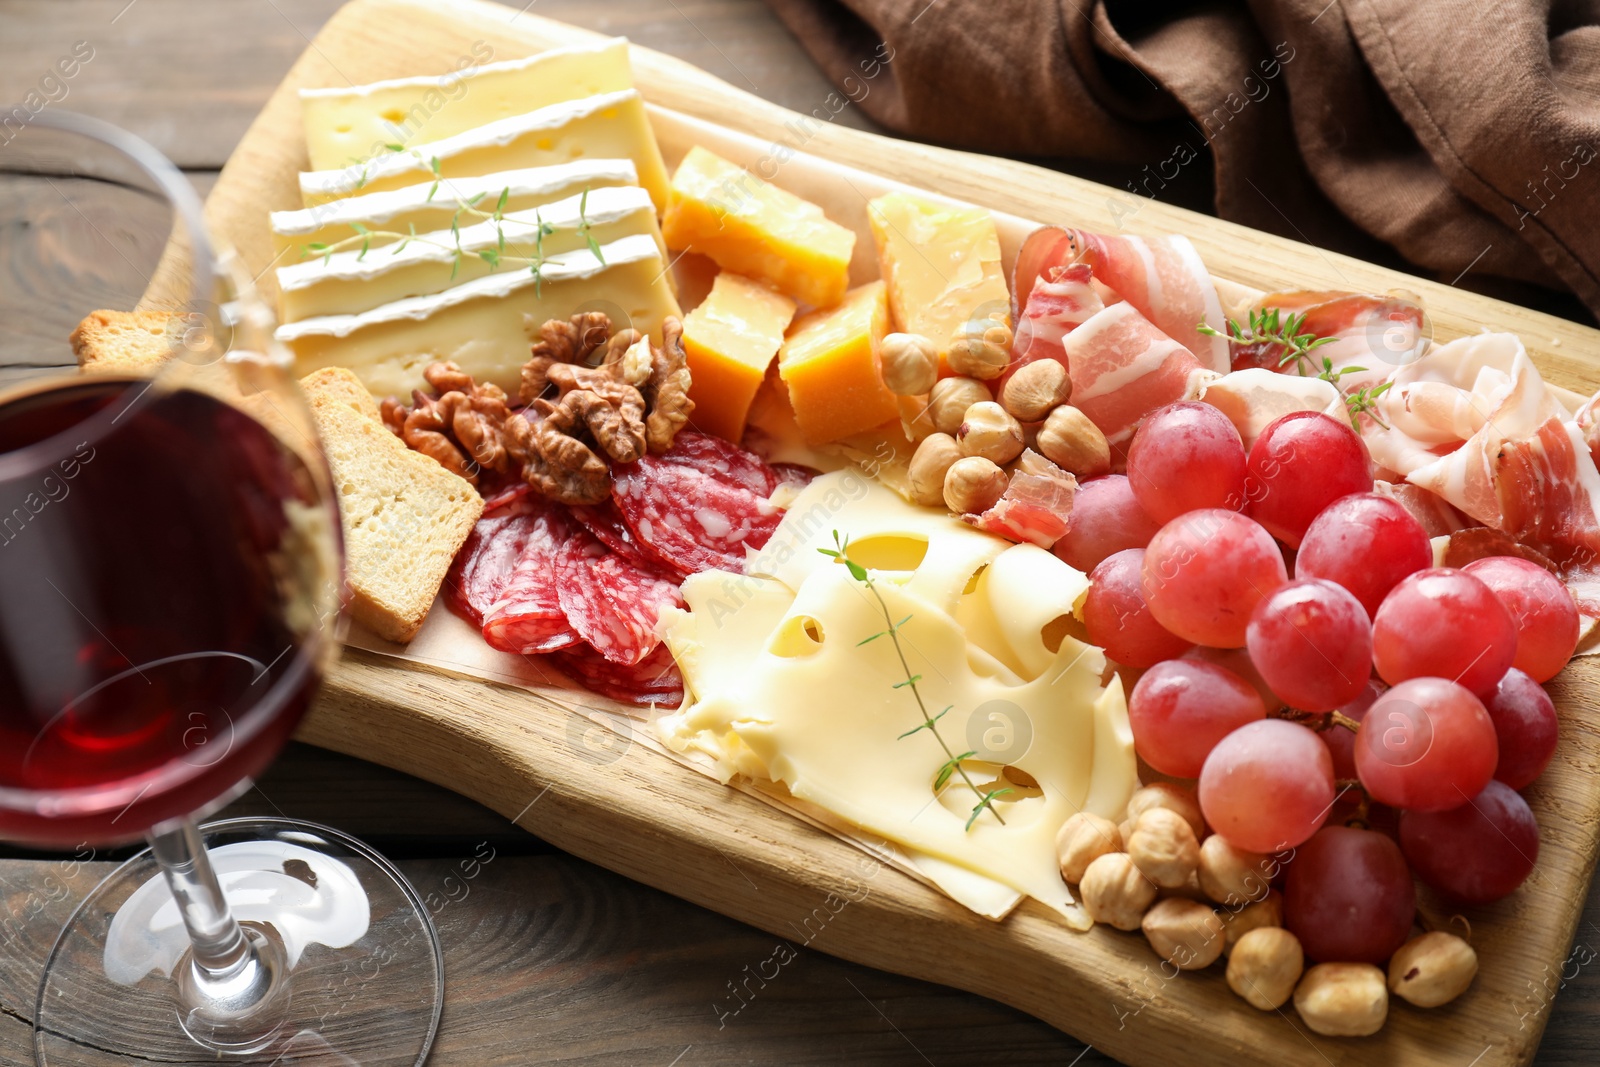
[299,90,667,211]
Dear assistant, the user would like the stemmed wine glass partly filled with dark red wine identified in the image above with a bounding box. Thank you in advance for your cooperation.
[0,109,443,1067]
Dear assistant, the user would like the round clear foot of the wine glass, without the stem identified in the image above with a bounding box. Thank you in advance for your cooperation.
[34,819,445,1067]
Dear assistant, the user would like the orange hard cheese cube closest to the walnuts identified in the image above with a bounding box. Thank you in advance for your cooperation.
[683,270,795,442]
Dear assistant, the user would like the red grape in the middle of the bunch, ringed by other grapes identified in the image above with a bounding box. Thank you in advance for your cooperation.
[1246,577,1373,712]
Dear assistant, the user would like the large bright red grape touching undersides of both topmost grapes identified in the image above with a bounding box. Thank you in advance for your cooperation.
[1142,507,1288,648]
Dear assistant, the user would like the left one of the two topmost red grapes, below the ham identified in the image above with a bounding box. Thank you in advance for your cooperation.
[1128,400,1245,523]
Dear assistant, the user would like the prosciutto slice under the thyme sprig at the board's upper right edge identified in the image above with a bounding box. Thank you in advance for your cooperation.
[1232,290,1429,394]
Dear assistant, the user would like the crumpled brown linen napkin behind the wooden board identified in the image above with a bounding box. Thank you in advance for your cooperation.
[768,0,1600,314]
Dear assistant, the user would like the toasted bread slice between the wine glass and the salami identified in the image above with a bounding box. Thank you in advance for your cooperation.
[301,368,483,641]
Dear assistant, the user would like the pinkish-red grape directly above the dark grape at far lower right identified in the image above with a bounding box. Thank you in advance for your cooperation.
[1355,678,1499,811]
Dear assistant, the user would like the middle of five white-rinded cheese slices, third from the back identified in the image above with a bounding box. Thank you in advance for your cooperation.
[272,160,638,264]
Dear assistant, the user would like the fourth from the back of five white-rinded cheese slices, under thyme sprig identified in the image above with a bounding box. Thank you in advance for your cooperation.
[278,186,666,322]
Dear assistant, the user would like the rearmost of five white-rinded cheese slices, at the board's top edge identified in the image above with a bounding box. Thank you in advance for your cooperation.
[301,37,634,170]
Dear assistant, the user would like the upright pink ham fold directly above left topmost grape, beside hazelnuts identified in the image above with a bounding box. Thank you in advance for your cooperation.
[1066,302,1216,445]
